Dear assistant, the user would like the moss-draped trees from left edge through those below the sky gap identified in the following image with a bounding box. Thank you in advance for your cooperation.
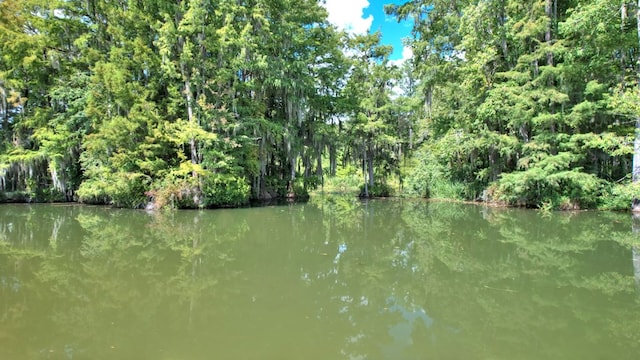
[0,0,410,207]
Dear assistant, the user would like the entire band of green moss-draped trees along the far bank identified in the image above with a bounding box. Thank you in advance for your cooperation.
[0,0,640,209]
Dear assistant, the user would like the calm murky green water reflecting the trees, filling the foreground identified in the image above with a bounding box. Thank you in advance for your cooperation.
[0,198,640,360]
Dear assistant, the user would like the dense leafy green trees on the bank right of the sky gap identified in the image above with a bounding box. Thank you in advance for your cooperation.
[387,0,640,209]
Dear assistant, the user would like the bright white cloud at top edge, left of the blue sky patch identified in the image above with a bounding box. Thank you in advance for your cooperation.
[324,0,373,34]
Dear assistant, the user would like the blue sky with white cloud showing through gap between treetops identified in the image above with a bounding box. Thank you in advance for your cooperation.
[325,0,412,62]
